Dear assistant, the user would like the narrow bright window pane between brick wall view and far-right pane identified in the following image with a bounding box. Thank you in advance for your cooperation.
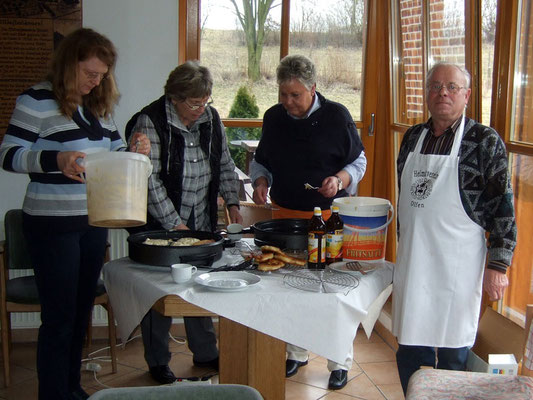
[481,0,496,125]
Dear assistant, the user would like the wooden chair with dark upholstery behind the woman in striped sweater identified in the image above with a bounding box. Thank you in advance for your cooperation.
[0,210,117,387]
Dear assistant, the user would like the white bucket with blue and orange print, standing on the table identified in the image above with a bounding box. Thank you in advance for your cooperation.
[333,197,394,262]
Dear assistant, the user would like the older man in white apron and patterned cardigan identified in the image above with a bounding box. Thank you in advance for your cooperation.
[393,63,516,392]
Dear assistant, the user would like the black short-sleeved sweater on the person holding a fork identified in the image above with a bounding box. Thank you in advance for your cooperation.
[255,92,363,211]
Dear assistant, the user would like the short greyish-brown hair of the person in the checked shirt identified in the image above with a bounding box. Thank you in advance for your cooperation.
[165,61,213,101]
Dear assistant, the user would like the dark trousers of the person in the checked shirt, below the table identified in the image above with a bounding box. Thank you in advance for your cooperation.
[141,310,218,367]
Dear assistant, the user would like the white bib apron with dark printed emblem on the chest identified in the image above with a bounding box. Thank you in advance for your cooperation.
[392,118,487,348]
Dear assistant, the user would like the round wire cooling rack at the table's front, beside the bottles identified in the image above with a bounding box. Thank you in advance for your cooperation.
[283,269,359,295]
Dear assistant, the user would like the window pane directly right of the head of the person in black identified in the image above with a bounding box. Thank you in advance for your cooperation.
[289,0,365,120]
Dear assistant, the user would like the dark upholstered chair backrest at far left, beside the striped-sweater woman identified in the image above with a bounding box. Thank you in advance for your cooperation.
[4,210,32,269]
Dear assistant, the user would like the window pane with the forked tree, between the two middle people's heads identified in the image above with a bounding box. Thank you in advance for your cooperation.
[200,0,281,118]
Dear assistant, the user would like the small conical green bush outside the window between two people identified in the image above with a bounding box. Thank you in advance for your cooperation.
[226,86,261,171]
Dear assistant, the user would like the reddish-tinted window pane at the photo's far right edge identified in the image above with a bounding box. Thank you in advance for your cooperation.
[511,0,533,144]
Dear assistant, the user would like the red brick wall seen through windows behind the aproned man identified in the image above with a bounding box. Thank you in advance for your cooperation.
[399,0,465,119]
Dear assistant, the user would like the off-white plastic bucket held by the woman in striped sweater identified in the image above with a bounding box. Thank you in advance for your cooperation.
[82,151,152,228]
